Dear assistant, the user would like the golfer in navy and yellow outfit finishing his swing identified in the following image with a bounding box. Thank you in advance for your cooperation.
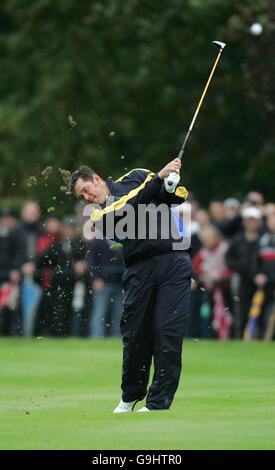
[69,159,192,413]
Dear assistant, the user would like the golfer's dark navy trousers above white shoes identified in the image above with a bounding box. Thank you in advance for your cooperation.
[121,251,192,410]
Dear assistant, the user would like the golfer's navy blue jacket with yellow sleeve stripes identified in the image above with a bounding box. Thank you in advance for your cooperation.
[91,168,188,267]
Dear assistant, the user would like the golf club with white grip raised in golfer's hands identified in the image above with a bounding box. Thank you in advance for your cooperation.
[165,41,226,192]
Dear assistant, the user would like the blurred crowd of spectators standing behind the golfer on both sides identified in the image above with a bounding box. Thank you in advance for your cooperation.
[0,191,275,340]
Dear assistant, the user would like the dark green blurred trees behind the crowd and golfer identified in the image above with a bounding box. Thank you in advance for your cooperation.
[0,0,275,207]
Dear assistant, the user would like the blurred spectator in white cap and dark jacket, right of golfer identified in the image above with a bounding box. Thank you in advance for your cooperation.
[226,207,262,337]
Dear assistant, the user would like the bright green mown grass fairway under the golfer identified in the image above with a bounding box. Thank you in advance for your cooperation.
[0,339,275,450]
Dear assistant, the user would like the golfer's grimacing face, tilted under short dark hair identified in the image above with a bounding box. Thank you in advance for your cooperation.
[75,175,107,204]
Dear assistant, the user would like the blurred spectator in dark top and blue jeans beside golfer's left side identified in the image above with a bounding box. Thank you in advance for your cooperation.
[88,239,124,338]
